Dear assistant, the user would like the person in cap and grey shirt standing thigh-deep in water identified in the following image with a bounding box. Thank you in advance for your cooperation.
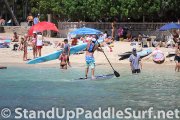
[129,48,142,74]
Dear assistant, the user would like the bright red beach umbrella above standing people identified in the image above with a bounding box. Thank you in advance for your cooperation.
[28,21,59,36]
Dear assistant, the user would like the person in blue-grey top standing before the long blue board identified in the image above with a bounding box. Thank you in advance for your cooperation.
[63,39,71,66]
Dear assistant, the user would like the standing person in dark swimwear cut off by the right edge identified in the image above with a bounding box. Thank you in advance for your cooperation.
[174,43,180,72]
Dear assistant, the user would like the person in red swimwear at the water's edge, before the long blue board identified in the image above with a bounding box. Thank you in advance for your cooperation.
[59,51,67,69]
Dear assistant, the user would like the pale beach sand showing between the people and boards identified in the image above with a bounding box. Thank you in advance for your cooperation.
[0,33,175,66]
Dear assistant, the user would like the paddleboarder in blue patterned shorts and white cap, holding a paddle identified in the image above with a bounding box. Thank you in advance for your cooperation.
[85,38,103,79]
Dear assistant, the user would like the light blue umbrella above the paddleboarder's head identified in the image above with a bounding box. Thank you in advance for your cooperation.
[70,27,102,35]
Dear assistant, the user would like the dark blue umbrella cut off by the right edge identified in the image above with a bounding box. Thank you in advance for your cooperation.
[159,23,180,31]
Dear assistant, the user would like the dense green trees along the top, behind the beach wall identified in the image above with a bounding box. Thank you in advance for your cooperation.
[5,0,180,21]
